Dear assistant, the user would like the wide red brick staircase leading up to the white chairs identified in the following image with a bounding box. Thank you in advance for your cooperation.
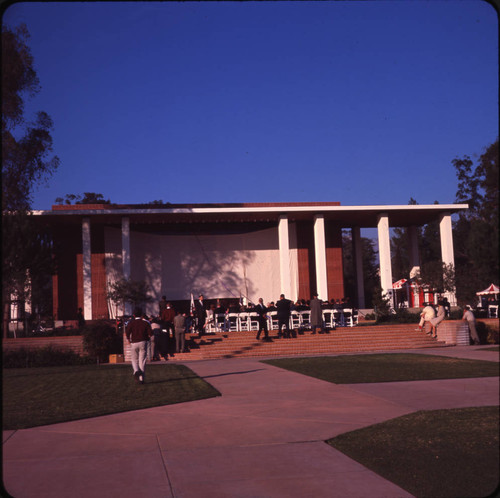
[169,324,446,361]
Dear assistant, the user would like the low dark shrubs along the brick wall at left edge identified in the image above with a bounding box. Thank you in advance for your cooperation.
[3,346,93,368]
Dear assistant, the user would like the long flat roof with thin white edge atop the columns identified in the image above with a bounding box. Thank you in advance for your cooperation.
[33,202,469,228]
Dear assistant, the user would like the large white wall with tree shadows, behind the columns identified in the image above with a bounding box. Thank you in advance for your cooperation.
[105,224,297,313]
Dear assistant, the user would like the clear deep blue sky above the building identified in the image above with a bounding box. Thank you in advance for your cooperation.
[3,0,499,209]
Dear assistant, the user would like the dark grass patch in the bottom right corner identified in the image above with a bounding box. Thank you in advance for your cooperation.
[327,406,500,498]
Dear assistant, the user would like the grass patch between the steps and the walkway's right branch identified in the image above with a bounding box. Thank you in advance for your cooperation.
[264,353,499,384]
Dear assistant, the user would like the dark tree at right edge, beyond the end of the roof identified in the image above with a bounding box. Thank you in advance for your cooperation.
[452,138,499,303]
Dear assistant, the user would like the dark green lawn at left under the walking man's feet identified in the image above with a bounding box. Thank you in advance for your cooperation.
[2,365,220,430]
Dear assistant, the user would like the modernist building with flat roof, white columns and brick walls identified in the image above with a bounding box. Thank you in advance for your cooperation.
[34,202,467,320]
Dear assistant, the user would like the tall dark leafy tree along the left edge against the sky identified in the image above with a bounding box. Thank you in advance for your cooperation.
[2,25,59,336]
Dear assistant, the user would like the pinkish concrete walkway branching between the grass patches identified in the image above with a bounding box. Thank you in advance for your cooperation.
[3,346,499,498]
